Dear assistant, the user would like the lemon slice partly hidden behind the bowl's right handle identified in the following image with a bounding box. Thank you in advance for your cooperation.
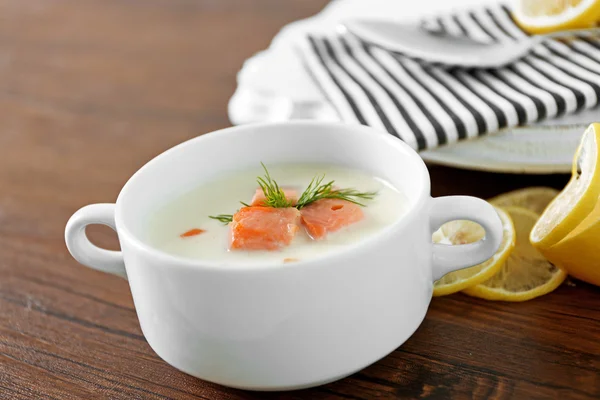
[433,209,515,296]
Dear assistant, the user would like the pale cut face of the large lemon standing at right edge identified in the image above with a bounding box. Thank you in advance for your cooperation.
[530,123,600,249]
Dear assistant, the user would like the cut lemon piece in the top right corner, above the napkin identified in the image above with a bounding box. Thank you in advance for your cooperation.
[512,0,600,34]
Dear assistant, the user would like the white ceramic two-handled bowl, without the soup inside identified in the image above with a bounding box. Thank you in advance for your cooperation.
[65,122,502,390]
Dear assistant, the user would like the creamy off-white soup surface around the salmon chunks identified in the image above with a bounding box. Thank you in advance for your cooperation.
[147,164,407,264]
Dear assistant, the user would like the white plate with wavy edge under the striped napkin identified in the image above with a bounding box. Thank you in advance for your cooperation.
[229,0,600,174]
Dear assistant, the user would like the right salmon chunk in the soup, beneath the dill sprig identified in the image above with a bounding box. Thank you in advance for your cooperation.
[301,199,364,240]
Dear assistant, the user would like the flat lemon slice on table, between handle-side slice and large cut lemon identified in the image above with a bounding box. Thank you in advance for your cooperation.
[463,207,567,301]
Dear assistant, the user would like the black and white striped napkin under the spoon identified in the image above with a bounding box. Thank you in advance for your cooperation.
[300,4,600,150]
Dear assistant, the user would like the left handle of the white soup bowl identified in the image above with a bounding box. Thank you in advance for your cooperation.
[65,204,127,279]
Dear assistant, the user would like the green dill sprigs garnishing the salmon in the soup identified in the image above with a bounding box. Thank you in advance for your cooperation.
[209,162,377,224]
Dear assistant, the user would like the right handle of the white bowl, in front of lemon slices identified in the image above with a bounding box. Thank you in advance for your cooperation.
[430,196,503,281]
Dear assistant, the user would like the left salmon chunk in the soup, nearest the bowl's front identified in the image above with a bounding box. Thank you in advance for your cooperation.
[229,206,300,250]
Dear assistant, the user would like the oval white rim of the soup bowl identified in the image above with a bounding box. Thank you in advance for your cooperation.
[115,121,431,272]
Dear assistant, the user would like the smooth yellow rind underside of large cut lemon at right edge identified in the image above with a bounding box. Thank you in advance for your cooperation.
[540,201,600,286]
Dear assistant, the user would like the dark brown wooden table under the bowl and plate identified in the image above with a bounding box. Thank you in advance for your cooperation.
[0,0,600,399]
